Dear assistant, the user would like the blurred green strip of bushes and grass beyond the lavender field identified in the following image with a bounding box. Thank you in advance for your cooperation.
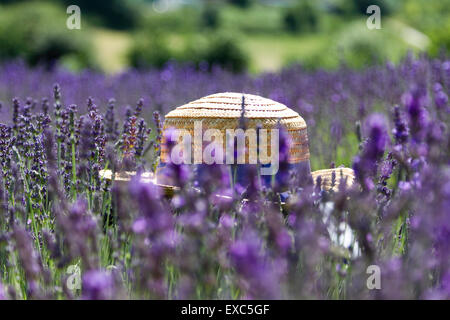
[0,0,450,73]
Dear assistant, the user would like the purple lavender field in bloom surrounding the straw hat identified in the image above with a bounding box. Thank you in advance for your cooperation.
[0,56,450,299]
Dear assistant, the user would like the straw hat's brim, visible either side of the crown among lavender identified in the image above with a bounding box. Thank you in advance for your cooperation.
[100,168,355,197]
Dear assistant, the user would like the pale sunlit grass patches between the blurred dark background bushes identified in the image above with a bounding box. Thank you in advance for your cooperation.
[94,23,424,73]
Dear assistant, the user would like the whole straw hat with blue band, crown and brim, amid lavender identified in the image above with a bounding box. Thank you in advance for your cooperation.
[102,92,354,194]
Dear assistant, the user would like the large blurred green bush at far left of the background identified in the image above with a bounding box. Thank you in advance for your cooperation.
[0,1,95,69]
